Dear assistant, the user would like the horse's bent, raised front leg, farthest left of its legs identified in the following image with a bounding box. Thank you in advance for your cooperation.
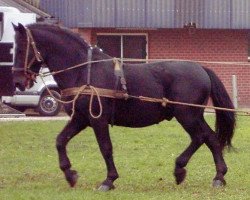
[56,114,87,187]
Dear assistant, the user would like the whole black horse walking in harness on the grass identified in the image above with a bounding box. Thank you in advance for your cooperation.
[13,24,235,191]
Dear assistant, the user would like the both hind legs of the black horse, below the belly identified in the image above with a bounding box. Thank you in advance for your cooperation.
[174,110,227,187]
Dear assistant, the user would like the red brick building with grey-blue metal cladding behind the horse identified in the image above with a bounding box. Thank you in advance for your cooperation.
[40,0,250,107]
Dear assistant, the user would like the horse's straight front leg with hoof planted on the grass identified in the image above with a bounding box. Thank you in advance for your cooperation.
[91,119,119,191]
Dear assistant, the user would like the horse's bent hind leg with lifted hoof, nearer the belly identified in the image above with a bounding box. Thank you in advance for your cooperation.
[174,114,204,184]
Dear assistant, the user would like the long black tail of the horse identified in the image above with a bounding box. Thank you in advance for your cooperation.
[204,67,236,148]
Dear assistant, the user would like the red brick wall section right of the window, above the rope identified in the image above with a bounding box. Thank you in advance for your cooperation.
[149,29,248,62]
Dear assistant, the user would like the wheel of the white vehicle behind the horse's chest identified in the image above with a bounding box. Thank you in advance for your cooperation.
[37,90,61,116]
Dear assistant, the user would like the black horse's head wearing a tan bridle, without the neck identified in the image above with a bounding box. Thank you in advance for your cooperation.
[12,23,43,91]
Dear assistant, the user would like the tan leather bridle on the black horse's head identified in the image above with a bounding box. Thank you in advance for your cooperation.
[12,27,44,81]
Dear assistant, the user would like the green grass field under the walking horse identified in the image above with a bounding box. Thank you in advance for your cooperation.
[0,116,250,200]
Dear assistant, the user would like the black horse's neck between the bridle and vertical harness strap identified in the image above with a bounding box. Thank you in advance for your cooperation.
[33,33,87,89]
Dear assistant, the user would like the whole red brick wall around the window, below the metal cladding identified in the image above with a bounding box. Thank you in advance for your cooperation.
[79,29,250,107]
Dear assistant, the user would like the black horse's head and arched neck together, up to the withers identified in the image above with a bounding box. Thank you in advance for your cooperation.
[13,23,110,90]
